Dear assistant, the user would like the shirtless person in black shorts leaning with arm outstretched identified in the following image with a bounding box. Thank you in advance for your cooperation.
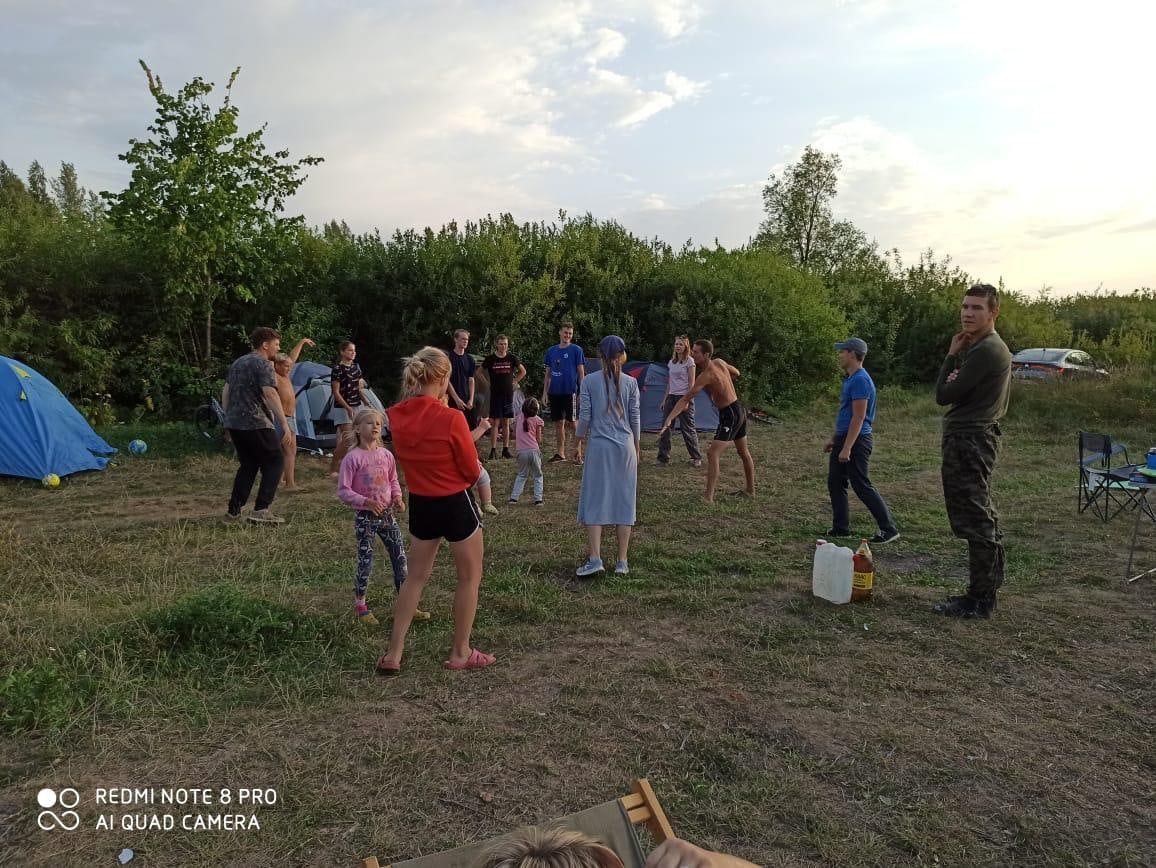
[659,341,755,503]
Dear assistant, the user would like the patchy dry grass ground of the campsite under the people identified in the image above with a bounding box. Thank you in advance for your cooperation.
[0,386,1156,866]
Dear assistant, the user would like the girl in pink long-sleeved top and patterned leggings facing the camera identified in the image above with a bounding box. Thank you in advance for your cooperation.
[338,407,430,626]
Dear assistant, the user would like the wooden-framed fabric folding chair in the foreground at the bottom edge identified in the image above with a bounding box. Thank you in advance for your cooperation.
[362,778,674,868]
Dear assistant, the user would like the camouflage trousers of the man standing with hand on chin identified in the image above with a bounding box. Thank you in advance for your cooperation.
[941,424,1003,600]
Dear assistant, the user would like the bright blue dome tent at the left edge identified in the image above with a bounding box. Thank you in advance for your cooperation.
[0,356,116,480]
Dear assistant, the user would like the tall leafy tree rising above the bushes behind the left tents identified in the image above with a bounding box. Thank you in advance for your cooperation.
[102,60,321,370]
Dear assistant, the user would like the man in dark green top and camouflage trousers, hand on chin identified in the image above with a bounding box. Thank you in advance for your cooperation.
[934,283,1012,618]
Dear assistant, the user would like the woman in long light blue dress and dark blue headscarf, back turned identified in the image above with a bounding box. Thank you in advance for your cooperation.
[577,334,642,577]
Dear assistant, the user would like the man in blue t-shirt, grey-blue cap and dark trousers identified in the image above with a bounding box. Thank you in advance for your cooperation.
[823,337,899,543]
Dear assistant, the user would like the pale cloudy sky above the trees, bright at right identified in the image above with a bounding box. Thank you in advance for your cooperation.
[0,0,1156,295]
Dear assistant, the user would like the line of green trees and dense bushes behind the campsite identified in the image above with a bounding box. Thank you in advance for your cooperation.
[0,64,1156,416]
